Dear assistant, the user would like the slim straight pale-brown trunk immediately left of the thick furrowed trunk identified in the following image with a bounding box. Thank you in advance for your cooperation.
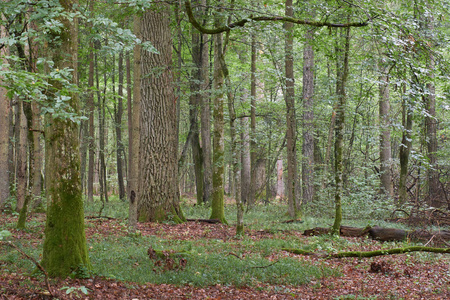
[127,15,142,232]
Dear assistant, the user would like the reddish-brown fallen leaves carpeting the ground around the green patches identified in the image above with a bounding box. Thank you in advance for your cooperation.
[0,215,450,300]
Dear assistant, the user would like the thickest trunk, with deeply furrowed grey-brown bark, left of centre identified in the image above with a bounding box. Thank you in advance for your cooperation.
[138,3,184,222]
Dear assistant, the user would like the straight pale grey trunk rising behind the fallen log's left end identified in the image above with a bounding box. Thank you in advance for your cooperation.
[302,25,314,203]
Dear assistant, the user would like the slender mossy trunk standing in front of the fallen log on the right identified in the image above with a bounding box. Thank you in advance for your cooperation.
[332,28,350,235]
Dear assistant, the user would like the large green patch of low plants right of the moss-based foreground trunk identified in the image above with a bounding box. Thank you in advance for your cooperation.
[90,237,339,286]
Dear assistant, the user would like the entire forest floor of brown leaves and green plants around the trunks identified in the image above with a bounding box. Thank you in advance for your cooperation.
[0,198,450,299]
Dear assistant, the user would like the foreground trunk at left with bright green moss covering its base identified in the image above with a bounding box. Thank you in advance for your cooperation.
[42,0,90,277]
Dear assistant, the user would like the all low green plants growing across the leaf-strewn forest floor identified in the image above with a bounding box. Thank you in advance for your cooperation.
[0,197,444,286]
